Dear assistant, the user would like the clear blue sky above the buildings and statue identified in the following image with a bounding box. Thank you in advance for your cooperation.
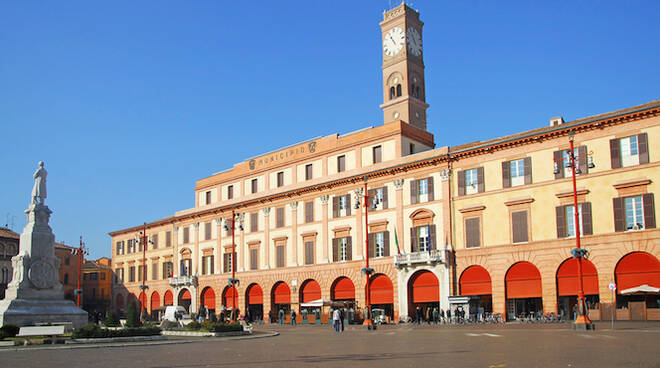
[0,0,660,258]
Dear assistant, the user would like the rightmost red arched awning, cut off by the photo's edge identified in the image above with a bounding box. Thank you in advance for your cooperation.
[614,252,660,292]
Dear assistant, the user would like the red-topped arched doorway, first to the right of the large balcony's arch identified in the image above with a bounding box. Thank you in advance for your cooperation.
[459,265,493,318]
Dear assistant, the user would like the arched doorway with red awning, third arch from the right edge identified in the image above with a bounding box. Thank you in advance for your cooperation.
[505,262,543,321]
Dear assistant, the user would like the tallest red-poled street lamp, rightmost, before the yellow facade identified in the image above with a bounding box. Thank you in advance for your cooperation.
[555,131,596,330]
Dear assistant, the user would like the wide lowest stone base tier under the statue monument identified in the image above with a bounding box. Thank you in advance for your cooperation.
[0,299,88,328]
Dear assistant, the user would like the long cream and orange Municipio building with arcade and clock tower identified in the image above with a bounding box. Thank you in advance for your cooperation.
[110,4,660,321]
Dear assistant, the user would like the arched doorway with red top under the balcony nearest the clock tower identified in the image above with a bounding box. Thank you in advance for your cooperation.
[408,270,440,321]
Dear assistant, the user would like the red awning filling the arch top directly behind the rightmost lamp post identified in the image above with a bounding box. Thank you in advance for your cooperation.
[557,258,598,296]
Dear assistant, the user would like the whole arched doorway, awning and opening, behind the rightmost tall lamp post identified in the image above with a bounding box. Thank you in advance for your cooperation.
[557,258,600,319]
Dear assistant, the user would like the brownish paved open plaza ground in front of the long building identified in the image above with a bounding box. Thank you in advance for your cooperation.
[0,322,660,368]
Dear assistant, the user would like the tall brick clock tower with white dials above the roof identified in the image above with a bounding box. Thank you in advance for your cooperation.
[380,3,429,131]
